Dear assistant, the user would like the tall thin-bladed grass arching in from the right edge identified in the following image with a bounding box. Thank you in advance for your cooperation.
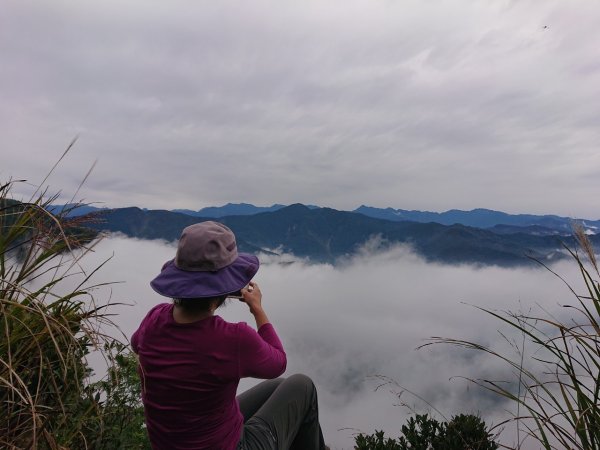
[427,228,600,450]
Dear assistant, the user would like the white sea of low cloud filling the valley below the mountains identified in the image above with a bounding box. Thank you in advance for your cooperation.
[67,237,577,450]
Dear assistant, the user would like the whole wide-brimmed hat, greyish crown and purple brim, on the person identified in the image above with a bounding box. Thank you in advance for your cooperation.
[150,221,260,298]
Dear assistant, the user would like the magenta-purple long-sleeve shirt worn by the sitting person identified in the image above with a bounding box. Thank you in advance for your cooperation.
[131,304,286,450]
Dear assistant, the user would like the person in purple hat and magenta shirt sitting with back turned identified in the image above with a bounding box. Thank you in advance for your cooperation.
[131,221,327,450]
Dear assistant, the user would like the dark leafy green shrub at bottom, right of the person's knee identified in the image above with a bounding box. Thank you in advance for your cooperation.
[354,414,498,450]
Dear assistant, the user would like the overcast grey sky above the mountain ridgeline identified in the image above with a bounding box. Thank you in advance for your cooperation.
[0,0,600,219]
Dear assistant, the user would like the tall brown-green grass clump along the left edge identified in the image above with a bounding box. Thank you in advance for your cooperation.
[0,181,136,449]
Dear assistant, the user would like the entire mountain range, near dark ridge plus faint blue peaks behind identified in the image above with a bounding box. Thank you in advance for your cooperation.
[72,204,600,266]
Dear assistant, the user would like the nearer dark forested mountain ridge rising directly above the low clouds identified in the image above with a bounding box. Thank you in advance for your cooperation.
[82,204,600,266]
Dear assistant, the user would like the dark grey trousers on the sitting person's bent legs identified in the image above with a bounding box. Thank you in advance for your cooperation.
[237,374,325,450]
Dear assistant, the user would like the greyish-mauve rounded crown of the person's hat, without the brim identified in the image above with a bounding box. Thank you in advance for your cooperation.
[175,221,238,272]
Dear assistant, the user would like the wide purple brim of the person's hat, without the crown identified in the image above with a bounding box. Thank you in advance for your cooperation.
[150,253,260,298]
